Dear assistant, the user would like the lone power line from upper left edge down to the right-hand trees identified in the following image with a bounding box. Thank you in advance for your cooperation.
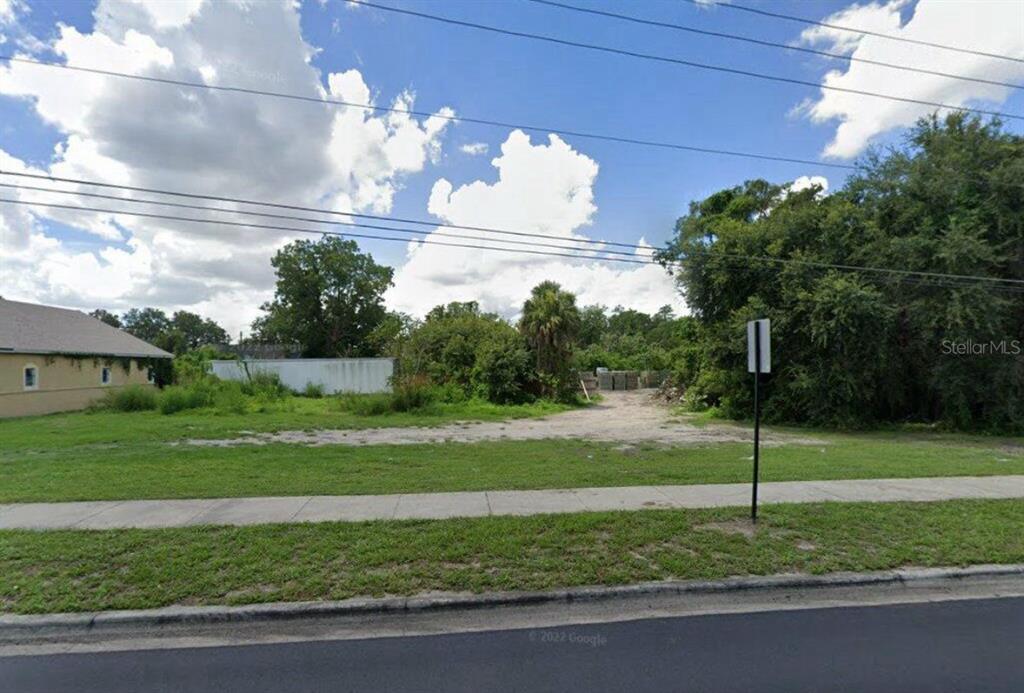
[0,54,857,171]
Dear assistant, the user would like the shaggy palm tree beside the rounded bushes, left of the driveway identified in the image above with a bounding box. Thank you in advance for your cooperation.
[519,281,580,395]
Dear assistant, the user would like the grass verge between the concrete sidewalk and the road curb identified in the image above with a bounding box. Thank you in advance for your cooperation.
[0,501,1024,613]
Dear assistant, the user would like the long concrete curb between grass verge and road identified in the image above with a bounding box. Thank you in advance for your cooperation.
[0,564,1024,636]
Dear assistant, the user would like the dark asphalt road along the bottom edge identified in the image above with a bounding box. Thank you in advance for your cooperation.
[0,598,1024,693]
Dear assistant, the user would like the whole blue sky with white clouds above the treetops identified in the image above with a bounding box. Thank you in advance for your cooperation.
[0,0,1024,334]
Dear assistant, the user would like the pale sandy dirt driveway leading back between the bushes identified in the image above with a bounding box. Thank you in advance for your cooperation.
[188,390,823,446]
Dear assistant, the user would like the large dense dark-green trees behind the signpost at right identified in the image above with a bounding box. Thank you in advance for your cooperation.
[659,114,1024,430]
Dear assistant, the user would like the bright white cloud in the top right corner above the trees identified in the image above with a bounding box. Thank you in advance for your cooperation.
[801,0,1024,159]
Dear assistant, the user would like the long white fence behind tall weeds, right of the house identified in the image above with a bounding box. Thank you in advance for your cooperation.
[210,358,394,394]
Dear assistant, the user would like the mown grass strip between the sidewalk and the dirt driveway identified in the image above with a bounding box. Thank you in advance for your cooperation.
[0,429,1024,503]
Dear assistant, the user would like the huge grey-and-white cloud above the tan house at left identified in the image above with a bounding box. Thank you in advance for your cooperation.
[0,0,453,334]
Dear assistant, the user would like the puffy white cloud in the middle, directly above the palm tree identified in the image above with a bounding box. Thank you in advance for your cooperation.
[387,130,685,317]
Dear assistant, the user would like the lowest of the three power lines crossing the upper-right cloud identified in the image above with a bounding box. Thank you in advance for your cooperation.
[345,0,1024,120]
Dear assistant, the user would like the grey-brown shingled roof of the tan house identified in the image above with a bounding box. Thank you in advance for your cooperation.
[0,299,172,358]
